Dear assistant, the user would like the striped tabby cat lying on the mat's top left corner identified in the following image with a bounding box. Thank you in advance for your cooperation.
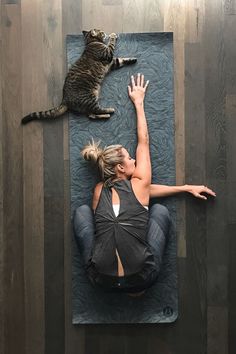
[22,29,137,124]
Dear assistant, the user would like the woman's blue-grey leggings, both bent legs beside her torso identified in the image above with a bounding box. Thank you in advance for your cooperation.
[74,204,171,273]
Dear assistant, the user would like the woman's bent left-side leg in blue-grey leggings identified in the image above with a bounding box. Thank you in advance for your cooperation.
[73,205,95,264]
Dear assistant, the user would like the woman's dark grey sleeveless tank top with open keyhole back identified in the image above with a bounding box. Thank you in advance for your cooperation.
[91,180,150,276]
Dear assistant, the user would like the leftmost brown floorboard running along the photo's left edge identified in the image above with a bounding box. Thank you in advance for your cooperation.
[1,5,25,354]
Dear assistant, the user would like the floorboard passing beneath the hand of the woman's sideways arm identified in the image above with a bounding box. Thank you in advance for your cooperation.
[185,43,207,353]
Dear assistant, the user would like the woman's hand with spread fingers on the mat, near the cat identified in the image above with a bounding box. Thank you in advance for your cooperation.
[128,74,149,105]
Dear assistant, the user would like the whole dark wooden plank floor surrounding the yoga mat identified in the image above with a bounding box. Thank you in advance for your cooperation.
[0,0,236,354]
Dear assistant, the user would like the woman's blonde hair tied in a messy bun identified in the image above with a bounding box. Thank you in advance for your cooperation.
[81,140,124,182]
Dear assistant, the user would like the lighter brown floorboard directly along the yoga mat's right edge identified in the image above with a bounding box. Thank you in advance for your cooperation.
[164,0,186,257]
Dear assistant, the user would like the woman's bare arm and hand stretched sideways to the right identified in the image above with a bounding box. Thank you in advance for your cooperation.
[150,184,216,200]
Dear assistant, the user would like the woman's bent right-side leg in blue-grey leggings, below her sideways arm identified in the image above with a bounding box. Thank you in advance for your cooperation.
[147,204,171,273]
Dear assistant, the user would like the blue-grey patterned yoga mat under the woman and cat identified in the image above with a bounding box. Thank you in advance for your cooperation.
[67,33,178,324]
